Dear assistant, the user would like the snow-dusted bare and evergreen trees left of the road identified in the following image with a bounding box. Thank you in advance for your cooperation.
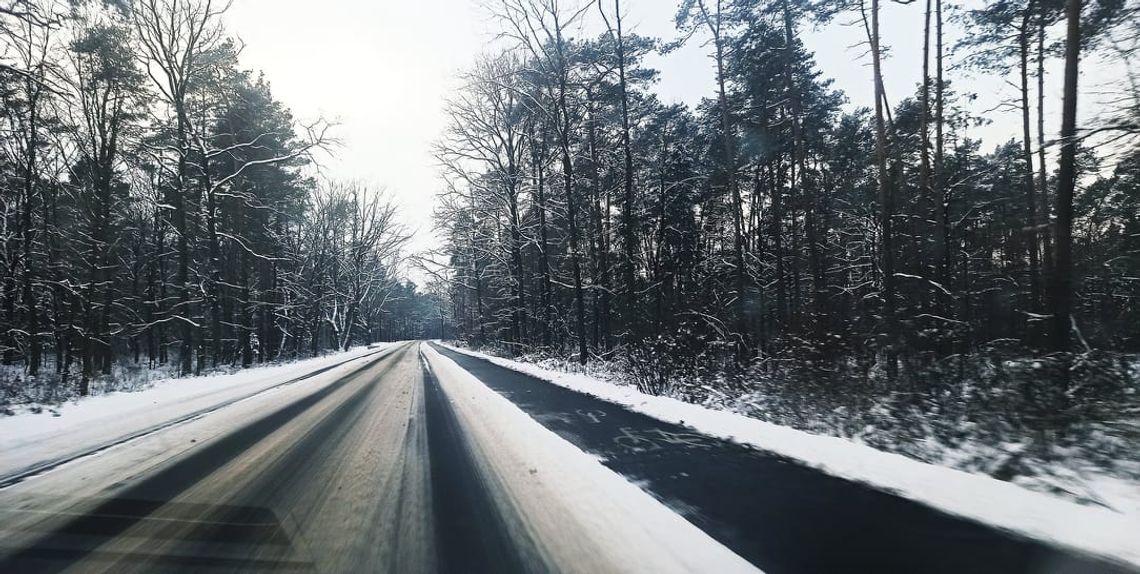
[0,0,415,395]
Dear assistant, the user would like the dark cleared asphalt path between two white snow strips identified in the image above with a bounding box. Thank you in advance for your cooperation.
[433,344,1132,574]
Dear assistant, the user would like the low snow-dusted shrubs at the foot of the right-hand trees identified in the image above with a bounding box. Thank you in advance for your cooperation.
[724,349,1140,505]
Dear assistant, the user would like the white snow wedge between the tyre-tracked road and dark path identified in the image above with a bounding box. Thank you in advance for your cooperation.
[421,344,757,573]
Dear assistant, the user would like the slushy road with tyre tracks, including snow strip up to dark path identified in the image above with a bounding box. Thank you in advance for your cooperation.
[0,344,755,572]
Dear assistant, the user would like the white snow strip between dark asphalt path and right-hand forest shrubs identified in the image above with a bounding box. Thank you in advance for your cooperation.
[433,345,1140,566]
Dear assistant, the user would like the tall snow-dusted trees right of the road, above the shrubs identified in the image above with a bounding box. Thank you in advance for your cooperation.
[438,0,1140,371]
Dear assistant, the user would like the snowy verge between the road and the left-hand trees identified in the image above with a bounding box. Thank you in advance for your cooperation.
[0,343,393,477]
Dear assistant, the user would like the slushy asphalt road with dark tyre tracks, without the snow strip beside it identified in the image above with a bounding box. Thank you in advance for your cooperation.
[0,345,533,573]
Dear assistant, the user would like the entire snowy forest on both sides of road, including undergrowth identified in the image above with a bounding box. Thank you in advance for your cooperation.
[0,0,1140,498]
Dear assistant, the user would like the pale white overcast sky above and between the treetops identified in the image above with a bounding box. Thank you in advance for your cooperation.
[227,0,1121,264]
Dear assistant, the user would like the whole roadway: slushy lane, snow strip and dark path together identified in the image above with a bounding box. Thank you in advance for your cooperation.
[0,344,1126,573]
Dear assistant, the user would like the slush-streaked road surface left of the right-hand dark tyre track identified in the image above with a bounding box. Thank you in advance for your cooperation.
[0,344,432,572]
